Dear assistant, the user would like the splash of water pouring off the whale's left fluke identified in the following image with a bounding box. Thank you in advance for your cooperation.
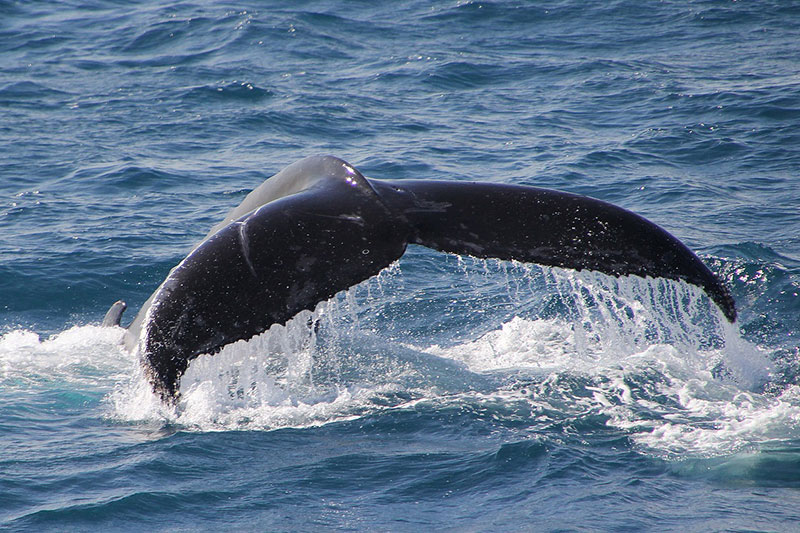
[109,267,432,431]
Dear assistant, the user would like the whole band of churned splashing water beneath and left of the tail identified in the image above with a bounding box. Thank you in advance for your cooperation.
[6,251,800,458]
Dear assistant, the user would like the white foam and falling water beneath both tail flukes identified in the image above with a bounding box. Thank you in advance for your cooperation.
[106,258,800,457]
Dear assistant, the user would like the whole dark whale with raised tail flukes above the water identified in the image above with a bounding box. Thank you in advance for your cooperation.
[108,155,736,403]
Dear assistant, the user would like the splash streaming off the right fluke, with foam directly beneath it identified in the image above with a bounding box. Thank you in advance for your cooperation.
[425,265,770,389]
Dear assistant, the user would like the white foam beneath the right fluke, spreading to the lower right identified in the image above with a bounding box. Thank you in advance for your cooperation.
[418,269,788,457]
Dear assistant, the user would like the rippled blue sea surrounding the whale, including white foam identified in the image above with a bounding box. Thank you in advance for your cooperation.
[0,0,800,531]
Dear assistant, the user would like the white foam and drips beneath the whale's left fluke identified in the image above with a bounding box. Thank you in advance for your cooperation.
[110,302,428,431]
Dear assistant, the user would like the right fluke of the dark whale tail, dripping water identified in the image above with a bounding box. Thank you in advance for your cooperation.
[371,180,736,322]
